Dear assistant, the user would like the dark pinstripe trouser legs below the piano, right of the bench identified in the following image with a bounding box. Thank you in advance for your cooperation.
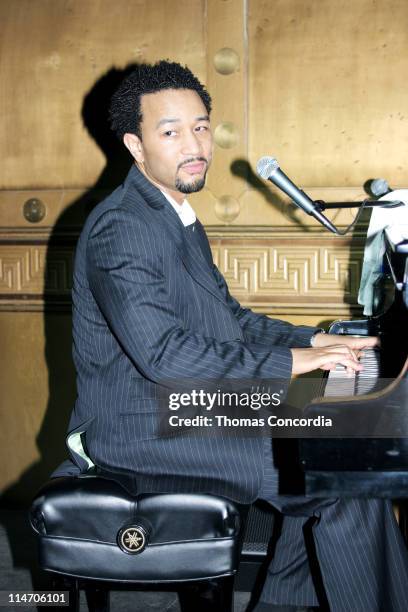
[258,438,408,612]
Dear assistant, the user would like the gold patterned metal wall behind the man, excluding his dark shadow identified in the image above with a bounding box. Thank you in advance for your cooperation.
[0,0,408,499]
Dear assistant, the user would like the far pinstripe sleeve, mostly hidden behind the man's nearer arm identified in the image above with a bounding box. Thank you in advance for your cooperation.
[213,265,320,348]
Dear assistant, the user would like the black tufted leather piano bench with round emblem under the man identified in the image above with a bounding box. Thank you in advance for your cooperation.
[30,473,248,612]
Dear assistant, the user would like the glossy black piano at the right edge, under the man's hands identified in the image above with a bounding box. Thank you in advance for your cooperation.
[299,226,408,498]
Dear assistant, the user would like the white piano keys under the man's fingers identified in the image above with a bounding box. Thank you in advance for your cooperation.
[324,348,380,397]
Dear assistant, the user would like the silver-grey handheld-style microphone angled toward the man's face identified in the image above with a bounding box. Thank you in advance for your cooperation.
[256,156,338,234]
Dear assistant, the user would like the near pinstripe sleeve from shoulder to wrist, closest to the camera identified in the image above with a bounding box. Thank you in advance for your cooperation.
[87,210,292,383]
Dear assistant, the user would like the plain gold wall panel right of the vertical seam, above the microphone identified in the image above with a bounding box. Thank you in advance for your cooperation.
[248,0,408,187]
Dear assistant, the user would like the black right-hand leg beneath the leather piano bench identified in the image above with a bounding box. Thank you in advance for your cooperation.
[179,576,234,612]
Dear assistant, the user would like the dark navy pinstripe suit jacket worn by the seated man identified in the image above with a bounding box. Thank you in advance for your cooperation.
[53,166,315,502]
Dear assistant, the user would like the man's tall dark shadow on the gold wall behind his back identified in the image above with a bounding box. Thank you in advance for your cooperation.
[0,64,139,505]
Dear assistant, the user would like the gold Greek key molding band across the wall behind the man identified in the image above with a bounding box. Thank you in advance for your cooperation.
[0,236,363,312]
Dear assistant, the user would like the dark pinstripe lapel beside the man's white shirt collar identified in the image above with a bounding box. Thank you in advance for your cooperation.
[124,166,225,304]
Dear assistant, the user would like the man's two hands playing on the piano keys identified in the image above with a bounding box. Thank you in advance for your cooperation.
[291,334,379,374]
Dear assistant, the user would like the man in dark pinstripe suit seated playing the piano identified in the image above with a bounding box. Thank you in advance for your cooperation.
[54,61,408,612]
